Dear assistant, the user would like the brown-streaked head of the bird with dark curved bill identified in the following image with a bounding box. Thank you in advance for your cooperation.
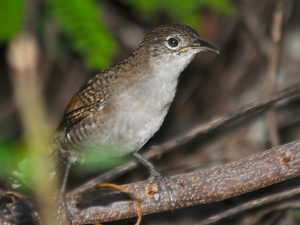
[139,24,219,76]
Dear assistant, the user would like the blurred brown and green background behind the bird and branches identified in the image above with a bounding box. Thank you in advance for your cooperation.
[0,0,300,225]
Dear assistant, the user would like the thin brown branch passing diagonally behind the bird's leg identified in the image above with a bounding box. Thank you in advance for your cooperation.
[72,84,300,194]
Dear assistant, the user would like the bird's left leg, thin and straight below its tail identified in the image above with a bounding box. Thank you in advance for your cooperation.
[58,160,72,225]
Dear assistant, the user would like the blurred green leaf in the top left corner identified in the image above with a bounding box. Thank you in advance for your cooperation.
[0,0,24,43]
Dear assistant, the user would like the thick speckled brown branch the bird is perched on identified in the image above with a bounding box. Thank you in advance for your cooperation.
[66,140,300,224]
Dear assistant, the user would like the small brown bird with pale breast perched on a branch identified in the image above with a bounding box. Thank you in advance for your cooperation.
[55,24,219,207]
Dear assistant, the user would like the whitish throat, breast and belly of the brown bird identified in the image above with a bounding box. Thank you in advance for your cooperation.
[86,53,196,154]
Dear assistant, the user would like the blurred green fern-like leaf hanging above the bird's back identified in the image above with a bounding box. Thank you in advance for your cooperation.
[48,0,117,68]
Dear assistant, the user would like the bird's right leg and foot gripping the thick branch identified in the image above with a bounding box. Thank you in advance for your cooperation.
[133,152,182,206]
